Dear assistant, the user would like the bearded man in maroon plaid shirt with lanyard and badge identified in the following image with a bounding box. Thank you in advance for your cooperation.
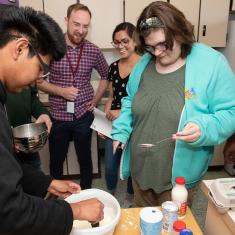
[38,3,108,189]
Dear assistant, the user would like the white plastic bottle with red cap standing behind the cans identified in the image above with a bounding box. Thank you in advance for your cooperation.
[171,176,188,219]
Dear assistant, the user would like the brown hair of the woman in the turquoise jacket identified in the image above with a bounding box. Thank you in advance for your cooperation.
[137,1,195,58]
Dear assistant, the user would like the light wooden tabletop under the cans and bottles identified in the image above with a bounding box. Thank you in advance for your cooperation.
[113,208,203,235]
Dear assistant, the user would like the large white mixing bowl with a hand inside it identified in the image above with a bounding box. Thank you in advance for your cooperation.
[65,188,121,235]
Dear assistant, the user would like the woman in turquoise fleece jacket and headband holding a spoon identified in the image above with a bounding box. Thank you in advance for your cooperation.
[112,1,235,206]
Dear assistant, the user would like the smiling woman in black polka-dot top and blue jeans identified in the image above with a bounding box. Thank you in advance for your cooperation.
[101,22,140,199]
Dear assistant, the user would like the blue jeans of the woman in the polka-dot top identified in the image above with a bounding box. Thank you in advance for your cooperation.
[105,138,133,194]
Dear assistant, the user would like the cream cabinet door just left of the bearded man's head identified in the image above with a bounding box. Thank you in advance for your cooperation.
[44,0,77,32]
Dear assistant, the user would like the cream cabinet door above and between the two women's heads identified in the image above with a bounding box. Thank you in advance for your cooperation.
[125,0,166,25]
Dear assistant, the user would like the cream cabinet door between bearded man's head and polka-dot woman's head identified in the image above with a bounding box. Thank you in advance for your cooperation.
[80,0,123,48]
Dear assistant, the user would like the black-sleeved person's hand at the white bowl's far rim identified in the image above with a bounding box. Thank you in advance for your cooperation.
[47,180,81,198]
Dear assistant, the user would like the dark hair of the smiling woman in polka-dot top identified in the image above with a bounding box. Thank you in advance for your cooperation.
[112,22,143,54]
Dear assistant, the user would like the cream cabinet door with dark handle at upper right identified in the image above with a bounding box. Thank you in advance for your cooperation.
[198,0,230,47]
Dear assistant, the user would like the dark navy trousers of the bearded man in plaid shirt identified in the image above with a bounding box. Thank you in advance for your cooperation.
[49,112,94,189]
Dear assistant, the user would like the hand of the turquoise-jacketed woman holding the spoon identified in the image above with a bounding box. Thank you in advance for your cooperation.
[172,122,201,142]
